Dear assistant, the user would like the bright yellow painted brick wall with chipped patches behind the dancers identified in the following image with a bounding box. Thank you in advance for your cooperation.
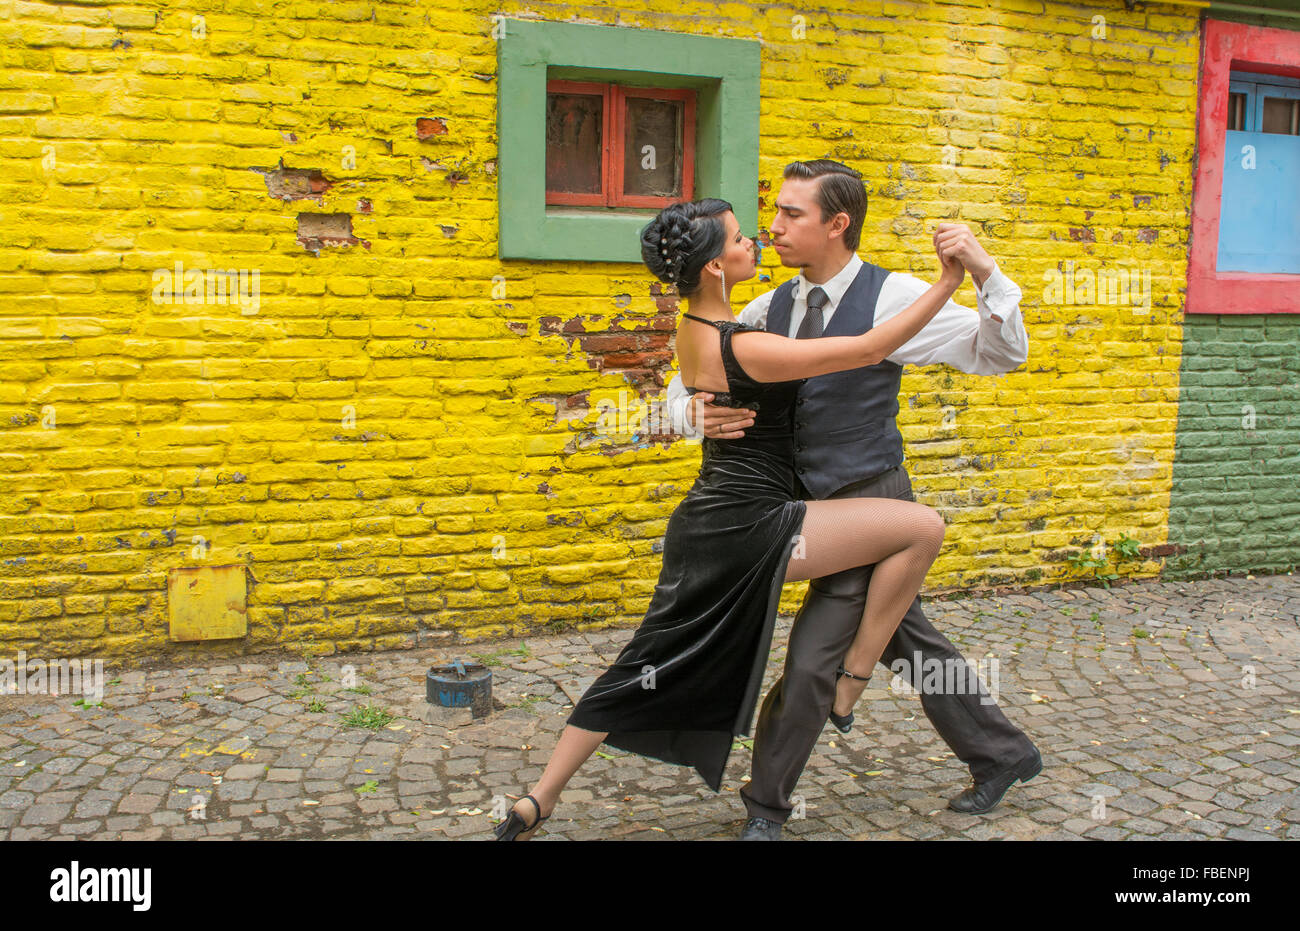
[0,0,1197,655]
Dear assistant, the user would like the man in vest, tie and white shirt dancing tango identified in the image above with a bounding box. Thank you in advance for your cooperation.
[668,159,1041,840]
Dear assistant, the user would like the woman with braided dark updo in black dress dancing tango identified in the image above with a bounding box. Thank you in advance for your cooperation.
[495,198,965,840]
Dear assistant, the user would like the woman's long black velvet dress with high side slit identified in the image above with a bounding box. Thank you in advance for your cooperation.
[568,313,806,792]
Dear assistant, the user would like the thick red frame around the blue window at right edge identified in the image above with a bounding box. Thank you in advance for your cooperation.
[1183,20,1300,313]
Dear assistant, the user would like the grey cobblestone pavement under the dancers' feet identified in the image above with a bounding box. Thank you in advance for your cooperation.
[0,576,1300,841]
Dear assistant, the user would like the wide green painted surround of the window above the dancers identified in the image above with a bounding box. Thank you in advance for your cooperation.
[497,18,762,261]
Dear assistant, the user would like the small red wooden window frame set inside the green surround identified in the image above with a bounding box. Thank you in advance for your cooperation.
[546,79,696,207]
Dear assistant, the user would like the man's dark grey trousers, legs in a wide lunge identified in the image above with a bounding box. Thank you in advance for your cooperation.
[741,466,1034,823]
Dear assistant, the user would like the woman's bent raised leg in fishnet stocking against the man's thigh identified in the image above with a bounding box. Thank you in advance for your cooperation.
[785,498,944,715]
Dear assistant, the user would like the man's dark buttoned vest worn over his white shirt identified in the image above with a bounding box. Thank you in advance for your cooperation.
[767,261,902,498]
